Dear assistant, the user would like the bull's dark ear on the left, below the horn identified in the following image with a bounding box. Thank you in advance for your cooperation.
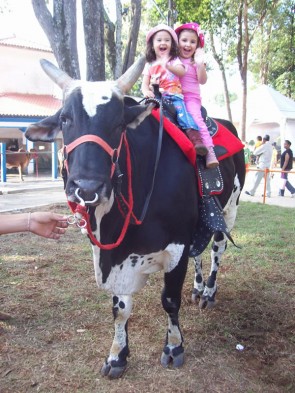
[25,108,62,142]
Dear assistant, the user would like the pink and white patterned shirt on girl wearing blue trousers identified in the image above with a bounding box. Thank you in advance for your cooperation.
[143,57,182,94]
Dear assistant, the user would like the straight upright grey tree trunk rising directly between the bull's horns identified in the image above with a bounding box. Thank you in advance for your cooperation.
[82,0,105,81]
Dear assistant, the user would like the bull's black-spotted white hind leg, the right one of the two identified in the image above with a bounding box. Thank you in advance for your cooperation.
[199,232,227,308]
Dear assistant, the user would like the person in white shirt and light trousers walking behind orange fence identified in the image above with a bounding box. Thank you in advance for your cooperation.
[245,134,272,198]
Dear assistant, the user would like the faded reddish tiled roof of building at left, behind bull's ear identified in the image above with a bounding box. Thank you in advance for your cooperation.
[0,93,62,117]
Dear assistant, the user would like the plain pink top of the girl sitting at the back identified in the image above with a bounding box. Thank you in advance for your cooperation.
[180,59,201,99]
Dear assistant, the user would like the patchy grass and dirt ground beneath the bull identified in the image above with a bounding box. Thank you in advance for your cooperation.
[0,202,295,393]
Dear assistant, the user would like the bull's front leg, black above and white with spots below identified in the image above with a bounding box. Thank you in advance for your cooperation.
[161,262,186,367]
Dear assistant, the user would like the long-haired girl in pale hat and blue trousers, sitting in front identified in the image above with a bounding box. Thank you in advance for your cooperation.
[141,24,208,155]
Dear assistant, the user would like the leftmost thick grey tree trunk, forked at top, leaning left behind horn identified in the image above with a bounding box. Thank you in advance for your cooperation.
[32,0,80,79]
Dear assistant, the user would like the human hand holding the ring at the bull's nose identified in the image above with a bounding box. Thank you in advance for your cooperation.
[28,212,68,240]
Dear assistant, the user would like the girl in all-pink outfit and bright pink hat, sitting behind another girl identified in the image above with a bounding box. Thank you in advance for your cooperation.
[175,23,219,168]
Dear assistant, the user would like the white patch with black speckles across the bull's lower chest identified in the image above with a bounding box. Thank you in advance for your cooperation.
[93,244,184,295]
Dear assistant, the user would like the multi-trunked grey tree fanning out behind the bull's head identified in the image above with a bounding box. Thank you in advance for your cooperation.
[32,0,142,81]
